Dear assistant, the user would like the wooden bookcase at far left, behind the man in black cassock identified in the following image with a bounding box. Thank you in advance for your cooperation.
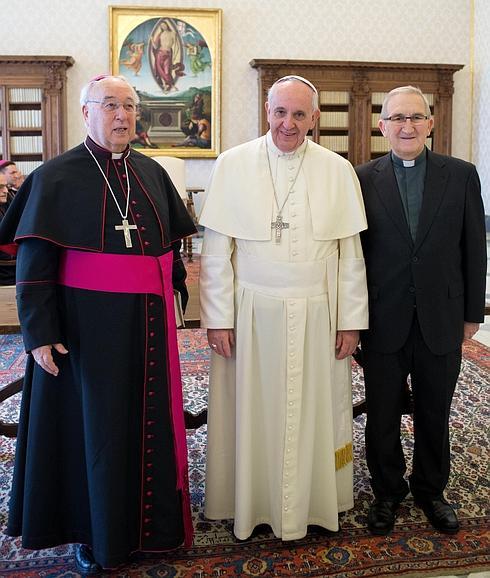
[0,56,74,174]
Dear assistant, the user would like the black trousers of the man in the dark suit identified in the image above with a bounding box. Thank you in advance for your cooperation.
[362,315,461,500]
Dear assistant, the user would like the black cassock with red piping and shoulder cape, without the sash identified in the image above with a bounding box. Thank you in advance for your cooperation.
[0,139,195,567]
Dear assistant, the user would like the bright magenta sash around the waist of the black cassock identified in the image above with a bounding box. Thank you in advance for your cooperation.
[58,249,193,546]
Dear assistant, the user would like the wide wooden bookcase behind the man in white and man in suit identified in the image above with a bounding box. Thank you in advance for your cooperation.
[250,59,463,165]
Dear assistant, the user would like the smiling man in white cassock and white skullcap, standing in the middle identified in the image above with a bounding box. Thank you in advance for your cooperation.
[200,76,368,540]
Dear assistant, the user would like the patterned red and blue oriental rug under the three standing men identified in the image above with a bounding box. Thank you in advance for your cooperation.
[0,329,490,578]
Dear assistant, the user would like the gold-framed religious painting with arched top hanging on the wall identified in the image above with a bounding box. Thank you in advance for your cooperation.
[109,6,221,158]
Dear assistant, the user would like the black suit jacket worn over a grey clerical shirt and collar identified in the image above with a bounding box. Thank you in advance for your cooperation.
[356,151,486,355]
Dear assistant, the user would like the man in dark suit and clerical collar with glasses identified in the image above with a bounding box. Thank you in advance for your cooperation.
[356,86,486,535]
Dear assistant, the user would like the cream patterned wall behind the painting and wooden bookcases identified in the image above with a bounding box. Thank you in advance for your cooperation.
[0,0,482,207]
